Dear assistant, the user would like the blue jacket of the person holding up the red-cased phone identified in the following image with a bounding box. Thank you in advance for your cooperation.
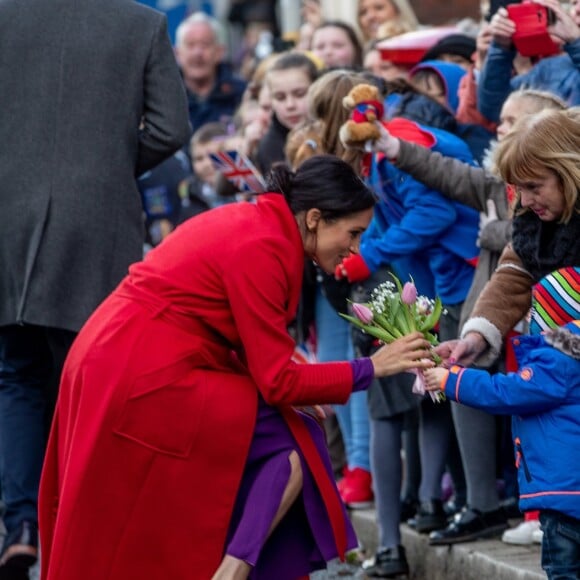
[477,39,580,122]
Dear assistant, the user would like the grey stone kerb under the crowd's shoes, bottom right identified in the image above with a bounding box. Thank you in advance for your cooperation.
[351,509,546,580]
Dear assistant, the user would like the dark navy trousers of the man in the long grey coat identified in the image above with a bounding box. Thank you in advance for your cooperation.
[0,325,76,533]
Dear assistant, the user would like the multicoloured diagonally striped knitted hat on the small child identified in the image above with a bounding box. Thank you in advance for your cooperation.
[530,267,580,334]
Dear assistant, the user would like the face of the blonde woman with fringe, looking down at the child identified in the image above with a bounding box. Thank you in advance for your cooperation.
[514,171,566,222]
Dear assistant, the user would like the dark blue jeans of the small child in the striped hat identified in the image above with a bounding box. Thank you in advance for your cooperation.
[540,510,580,580]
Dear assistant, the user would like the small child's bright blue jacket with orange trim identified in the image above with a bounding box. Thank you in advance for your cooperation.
[445,320,580,519]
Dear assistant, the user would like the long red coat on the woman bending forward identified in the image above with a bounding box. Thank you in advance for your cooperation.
[39,194,352,580]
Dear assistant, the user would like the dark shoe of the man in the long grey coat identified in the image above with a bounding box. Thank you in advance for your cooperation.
[0,521,38,579]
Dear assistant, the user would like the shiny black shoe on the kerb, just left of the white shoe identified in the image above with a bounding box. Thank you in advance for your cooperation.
[429,507,508,546]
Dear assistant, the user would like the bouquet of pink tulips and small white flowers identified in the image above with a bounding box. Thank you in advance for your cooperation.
[341,274,445,402]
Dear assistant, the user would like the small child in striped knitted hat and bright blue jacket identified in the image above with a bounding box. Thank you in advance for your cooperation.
[425,267,580,579]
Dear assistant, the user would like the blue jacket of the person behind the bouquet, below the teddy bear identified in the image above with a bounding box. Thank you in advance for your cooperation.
[360,125,479,305]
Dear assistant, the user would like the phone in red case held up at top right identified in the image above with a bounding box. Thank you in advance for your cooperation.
[506,2,560,57]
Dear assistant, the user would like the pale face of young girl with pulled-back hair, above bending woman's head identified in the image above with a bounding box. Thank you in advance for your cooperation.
[268,68,311,129]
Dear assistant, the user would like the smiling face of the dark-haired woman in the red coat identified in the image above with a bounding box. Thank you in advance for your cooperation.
[305,208,373,274]
